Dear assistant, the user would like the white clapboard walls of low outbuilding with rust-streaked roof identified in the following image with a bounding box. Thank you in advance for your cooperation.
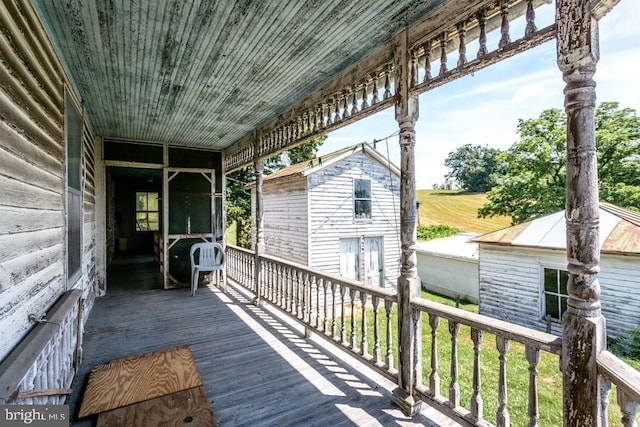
[479,245,640,337]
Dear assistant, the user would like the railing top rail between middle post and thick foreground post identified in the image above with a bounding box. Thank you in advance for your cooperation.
[411,298,562,355]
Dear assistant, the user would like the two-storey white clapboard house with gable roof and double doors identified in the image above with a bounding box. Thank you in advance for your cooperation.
[251,144,400,287]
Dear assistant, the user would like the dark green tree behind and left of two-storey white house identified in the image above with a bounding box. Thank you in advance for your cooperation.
[227,135,327,248]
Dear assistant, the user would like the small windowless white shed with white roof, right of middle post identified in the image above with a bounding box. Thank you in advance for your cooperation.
[416,233,478,304]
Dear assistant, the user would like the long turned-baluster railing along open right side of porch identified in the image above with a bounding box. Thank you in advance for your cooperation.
[227,245,640,426]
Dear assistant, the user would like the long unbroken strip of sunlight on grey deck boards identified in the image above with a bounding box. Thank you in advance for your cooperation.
[224,304,345,396]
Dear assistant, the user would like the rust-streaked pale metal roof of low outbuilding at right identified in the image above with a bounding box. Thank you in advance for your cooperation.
[471,202,640,255]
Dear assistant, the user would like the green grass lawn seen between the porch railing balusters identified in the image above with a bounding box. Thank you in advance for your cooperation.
[338,291,640,426]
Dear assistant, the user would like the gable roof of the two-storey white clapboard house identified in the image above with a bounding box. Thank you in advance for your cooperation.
[253,142,400,185]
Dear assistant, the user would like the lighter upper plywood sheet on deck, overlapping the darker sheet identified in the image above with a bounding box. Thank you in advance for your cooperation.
[78,346,202,418]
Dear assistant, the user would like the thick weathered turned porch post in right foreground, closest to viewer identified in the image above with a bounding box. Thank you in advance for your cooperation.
[556,0,606,426]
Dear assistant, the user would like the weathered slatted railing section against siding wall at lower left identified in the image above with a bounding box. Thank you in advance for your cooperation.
[0,290,82,405]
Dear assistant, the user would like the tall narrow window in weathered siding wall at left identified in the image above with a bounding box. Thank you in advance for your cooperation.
[64,90,82,284]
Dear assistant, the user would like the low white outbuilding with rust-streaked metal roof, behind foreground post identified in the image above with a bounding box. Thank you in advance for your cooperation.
[473,203,640,337]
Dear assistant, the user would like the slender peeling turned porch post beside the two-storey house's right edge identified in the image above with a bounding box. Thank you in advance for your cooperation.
[393,31,422,415]
